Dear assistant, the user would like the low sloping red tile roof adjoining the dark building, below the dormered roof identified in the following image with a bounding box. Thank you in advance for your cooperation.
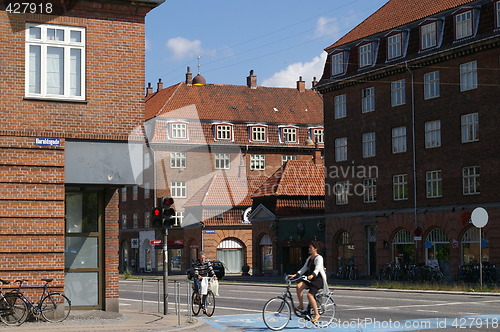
[252,160,325,198]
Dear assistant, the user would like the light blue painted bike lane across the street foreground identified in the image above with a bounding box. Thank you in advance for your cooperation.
[200,314,500,332]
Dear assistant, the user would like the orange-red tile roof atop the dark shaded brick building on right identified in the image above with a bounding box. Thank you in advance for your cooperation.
[325,0,476,51]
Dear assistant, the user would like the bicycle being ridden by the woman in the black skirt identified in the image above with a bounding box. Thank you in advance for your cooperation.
[262,275,336,331]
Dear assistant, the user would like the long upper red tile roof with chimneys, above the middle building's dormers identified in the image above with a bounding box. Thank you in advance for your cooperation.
[146,82,323,124]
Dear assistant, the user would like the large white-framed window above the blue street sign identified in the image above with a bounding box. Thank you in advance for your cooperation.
[25,23,85,100]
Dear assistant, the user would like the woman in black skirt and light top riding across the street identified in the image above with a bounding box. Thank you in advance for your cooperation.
[290,241,328,322]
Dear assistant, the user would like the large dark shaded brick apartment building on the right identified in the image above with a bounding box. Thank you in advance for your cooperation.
[317,0,500,279]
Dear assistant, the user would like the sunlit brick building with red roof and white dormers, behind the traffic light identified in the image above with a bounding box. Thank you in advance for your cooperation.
[120,68,323,272]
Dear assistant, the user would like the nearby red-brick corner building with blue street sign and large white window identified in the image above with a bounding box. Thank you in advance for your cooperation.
[0,0,163,311]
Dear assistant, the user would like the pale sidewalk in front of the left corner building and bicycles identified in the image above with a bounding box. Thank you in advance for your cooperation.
[0,310,204,332]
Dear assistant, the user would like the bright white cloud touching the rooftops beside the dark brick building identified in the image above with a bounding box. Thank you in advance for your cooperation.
[262,52,326,88]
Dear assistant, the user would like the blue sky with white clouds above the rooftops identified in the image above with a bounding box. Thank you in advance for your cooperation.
[146,0,387,88]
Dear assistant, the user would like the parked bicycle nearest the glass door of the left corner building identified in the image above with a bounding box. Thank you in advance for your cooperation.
[11,278,71,324]
